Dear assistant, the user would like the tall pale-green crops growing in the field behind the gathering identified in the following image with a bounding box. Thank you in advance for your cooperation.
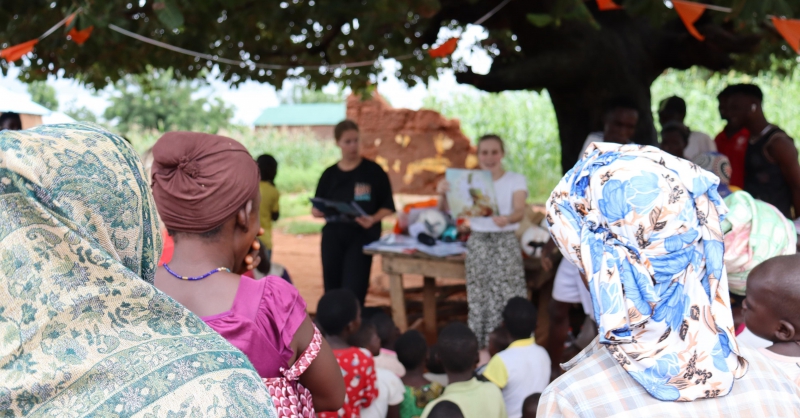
[129,65,800,209]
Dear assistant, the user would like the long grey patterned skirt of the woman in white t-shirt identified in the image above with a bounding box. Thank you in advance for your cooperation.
[465,232,528,347]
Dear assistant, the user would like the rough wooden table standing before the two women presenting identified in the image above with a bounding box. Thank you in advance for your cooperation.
[364,250,466,342]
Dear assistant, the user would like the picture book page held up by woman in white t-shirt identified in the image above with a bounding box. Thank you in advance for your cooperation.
[445,168,498,218]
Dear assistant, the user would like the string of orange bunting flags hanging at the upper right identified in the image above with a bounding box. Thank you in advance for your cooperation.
[595,0,800,49]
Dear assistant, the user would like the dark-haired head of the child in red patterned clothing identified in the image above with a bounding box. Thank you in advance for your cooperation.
[317,289,361,338]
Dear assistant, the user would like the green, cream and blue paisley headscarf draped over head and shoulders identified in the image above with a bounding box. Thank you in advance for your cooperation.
[0,124,275,417]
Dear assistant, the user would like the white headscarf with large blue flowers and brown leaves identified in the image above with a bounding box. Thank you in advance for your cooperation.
[547,143,747,401]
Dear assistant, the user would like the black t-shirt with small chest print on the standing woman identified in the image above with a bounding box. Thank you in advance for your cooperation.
[314,158,395,236]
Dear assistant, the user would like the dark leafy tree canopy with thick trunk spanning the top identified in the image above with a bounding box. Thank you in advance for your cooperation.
[0,0,800,167]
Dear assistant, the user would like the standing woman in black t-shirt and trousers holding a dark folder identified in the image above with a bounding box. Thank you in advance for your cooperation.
[311,120,395,306]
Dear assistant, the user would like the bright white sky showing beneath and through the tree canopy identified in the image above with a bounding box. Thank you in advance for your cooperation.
[0,25,492,125]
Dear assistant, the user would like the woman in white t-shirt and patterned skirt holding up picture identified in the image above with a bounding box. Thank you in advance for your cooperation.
[437,135,528,347]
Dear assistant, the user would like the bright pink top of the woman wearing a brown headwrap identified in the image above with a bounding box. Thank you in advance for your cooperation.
[202,276,306,378]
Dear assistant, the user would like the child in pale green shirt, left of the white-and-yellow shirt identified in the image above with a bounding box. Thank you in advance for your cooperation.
[422,322,507,418]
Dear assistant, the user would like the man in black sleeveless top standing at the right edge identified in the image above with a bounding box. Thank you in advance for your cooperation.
[727,84,800,219]
